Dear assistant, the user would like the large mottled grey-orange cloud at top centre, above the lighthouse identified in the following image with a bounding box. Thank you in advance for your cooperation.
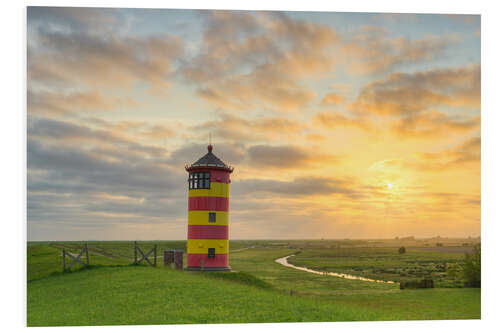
[183,11,338,111]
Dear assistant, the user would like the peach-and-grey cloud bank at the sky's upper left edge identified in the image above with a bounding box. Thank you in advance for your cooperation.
[28,22,183,91]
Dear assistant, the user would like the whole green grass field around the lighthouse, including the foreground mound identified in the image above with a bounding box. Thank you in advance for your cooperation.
[27,241,481,326]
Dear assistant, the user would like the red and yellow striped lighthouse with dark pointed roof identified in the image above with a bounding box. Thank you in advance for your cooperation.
[186,145,233,271]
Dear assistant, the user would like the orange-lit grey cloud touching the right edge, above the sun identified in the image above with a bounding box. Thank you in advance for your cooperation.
[349,65,481,116]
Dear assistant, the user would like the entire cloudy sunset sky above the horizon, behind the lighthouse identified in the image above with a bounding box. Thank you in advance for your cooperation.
[27,7,481,240]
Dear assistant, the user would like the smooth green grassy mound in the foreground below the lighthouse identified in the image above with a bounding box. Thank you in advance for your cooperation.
[28,266,377,326]
